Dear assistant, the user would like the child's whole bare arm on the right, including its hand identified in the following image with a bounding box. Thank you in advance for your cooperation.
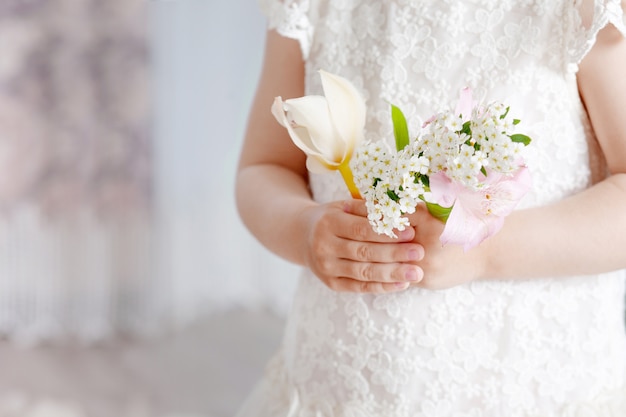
[394,26,626,288]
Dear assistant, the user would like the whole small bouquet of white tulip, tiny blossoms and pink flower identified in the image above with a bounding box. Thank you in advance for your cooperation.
[272,71,531,250]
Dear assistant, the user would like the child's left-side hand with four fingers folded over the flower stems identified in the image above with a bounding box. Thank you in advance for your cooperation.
[303,200,424,293]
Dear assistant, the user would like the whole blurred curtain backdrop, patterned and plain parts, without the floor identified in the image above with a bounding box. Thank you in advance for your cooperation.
[0,0,297,344]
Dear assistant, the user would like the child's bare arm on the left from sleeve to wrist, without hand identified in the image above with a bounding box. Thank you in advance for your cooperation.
[236,32,315,264]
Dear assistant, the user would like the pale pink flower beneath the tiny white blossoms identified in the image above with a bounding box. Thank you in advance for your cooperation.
[430,167,532,251]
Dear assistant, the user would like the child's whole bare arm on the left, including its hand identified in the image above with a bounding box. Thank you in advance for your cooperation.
[236,31,423,292]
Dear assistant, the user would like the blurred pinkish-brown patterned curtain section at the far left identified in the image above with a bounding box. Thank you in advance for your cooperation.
[0,0,154,344]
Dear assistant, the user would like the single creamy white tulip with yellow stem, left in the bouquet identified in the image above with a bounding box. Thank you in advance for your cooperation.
[272,70,365,198]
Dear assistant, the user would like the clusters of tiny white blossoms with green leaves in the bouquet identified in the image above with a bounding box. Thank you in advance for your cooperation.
[351,103,528,237]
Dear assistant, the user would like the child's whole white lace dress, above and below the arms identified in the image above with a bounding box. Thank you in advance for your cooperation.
[240,0,626,417]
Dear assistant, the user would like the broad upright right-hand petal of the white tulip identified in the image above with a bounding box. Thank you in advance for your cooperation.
[320,70,366,159]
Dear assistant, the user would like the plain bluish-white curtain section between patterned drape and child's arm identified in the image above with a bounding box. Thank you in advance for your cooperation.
[153,0,297,318]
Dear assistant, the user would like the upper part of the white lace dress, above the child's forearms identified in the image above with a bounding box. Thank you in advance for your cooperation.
[260,0,626,206]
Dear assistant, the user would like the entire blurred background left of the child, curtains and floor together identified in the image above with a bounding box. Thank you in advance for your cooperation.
[0,0,297,417]
